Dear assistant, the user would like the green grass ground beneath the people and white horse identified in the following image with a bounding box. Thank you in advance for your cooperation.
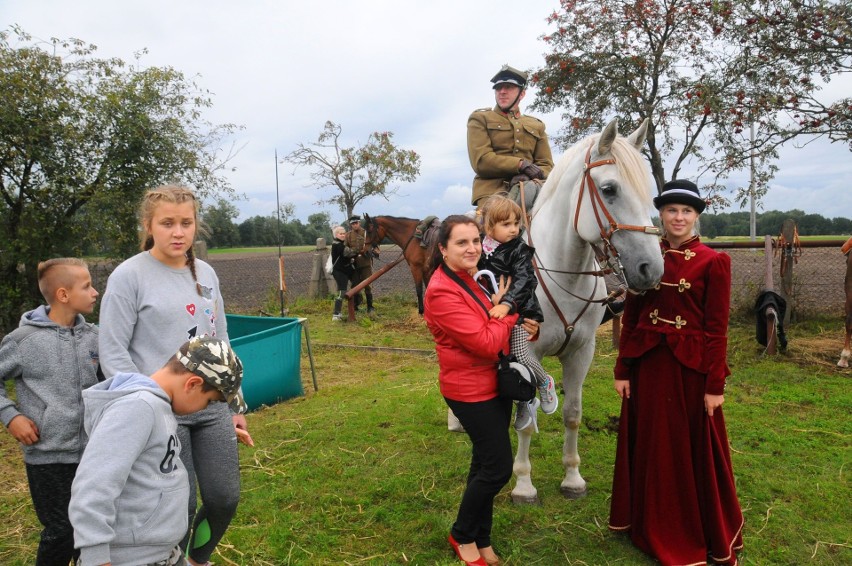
[0,298,852,566]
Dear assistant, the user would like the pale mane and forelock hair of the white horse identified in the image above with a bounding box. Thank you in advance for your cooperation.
[537,133,651,211]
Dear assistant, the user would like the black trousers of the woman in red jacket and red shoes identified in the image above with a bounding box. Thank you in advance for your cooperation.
[444,397,513,548]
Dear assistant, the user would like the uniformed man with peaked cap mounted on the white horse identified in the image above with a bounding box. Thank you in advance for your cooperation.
[467,65,553,209]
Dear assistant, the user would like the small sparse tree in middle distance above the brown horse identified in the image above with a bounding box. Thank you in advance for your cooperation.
[284,121,420,221]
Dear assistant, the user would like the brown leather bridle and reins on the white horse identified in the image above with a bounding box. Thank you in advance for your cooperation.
[520,143,660,356]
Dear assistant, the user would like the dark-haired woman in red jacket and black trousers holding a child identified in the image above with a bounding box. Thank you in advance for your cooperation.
[423,215,538,566]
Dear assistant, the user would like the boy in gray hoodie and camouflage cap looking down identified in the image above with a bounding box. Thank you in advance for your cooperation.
[69,336,243,566]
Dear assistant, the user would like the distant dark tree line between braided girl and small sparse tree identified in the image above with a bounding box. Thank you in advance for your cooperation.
[201,199,344,248]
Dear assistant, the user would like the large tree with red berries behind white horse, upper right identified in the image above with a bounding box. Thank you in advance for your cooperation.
[533,0,852,207]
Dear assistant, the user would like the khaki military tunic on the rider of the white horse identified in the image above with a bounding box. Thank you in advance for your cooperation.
[467,106,553,204]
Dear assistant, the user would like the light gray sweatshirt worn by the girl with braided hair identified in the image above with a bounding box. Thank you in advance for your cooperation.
[100,252,228,377]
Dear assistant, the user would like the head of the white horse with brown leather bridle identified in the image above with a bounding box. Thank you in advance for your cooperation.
[533,120,663,291]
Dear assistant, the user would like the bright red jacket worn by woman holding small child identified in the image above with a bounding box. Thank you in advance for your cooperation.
[423,268,518,403]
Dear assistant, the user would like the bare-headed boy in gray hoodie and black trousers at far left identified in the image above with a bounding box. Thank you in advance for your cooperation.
[0,258,99,566]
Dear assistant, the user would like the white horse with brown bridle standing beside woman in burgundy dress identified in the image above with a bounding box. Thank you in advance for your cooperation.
[512,120,663,503]
